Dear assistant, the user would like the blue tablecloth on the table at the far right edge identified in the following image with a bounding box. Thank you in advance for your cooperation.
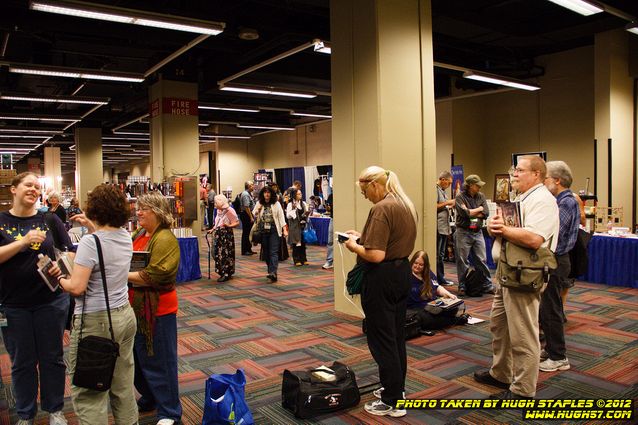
[585,235,638,288]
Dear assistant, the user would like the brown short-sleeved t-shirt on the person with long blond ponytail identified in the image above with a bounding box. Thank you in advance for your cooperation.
[360,194,416,261]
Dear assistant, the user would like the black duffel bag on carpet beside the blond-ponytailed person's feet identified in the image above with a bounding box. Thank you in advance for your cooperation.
[281,362,361,419]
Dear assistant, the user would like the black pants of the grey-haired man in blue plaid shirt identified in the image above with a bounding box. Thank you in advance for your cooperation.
[539,254,571,360]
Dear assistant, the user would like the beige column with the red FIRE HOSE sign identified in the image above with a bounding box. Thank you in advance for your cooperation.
[149,79,202,235]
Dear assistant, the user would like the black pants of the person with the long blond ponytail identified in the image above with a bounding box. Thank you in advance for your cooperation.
[361,259,410,407]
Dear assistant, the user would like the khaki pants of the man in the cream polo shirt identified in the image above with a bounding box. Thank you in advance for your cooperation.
[490,283,541,397]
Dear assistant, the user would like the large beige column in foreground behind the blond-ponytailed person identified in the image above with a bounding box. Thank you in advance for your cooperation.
[330,0,436,315]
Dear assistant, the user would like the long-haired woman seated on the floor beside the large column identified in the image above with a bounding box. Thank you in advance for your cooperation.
[407,251,468,330]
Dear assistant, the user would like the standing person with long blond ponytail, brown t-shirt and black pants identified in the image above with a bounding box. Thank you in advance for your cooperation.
[345,166,418,417]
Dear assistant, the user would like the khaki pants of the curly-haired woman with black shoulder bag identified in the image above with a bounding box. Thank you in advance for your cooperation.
[68,303,138,425]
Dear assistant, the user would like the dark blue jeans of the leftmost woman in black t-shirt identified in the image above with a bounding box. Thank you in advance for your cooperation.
[0,294,69,419]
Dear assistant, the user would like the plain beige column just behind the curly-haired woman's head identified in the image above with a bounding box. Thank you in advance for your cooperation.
[75,128,104,208]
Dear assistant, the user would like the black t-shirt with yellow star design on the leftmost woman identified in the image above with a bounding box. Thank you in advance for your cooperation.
[0,211,73,307]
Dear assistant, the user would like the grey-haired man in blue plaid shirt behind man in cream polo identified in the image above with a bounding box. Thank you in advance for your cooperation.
[539,161,580,372]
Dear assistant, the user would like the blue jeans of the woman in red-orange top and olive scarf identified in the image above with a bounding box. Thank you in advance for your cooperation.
[133,313,182,422]
